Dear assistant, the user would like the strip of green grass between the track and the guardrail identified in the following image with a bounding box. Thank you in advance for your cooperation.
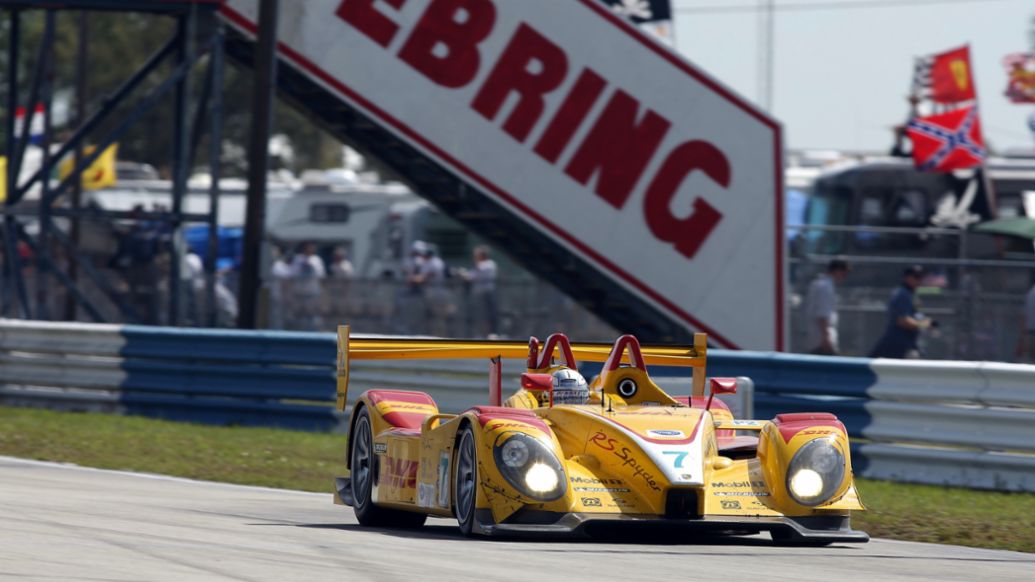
[0,407,1035,552]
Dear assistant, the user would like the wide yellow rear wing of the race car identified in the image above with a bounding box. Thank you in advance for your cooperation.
[337,325,708,410]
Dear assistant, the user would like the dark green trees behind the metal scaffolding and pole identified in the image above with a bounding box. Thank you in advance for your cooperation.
[0,10,341,176]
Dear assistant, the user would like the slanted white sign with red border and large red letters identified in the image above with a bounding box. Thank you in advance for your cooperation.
[223,0,783,349]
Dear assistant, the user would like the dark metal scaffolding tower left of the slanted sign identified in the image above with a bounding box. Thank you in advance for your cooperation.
[0,0,224,325]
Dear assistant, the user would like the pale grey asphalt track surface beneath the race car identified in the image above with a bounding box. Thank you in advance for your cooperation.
[0,457,1035,582]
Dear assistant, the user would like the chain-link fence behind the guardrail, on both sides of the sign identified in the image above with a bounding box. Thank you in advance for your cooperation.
[8,227,1035,361]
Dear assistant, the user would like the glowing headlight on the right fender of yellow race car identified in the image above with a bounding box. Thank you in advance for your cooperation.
[787,438,845,506]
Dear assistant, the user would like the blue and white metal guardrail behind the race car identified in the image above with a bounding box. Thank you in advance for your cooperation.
[0,320,1035,491]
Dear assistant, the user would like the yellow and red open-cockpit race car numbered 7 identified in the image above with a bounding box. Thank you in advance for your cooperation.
[334,326,868,546]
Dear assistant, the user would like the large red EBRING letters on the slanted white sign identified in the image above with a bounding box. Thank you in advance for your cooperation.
[335,0,733,259]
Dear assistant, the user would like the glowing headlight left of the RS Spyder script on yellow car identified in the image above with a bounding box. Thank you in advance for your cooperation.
[493,433,567,501]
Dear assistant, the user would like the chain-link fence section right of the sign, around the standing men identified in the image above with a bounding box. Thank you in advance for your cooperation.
[789,227,1035,361]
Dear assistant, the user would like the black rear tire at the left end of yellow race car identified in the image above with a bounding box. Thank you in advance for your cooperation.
[349,407,427,527]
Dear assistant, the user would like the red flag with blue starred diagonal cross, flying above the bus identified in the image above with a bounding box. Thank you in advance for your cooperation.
[906,106,986,172]
